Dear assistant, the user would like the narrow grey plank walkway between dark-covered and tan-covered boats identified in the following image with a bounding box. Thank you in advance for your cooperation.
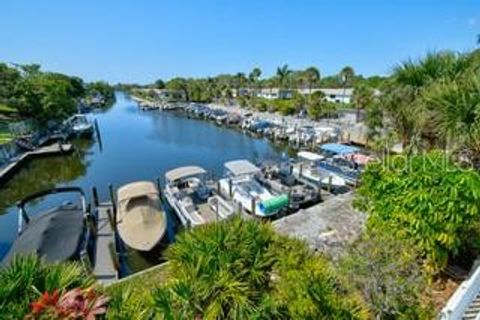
[93,203,118,284]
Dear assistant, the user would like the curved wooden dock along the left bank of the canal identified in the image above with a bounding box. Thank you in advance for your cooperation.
[0,143,73,183]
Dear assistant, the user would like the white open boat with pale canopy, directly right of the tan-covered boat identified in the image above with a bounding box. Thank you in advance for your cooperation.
[165,166,235,227]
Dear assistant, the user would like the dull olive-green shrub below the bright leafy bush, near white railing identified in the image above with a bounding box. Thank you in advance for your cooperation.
[339,230,434,319]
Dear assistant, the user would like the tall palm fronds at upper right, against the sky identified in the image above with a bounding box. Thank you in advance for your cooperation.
[369,50,480,160]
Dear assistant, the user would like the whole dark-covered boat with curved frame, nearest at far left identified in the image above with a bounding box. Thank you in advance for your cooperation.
[3,187,95,264]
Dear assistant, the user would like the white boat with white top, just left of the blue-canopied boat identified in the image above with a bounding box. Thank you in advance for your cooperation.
[292,151,347,188]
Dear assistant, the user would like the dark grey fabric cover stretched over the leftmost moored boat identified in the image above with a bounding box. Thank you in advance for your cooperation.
[3,206,85,263]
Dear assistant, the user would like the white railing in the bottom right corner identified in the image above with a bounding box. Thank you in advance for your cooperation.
[439,267,480,320]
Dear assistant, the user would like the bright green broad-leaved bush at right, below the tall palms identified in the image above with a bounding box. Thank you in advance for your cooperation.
[357,152,480,273]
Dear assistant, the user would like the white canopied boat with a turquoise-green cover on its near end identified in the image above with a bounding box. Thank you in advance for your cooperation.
[219,160,288,217]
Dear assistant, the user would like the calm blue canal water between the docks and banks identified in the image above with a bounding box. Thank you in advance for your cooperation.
[0,93,282,269]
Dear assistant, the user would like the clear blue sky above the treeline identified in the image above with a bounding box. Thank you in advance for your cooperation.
[0,0,480,83]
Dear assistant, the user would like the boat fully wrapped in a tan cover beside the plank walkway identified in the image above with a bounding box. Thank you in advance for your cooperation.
[117,181,167,251]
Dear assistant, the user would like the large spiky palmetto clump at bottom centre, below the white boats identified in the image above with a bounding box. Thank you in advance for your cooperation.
[153,218,361,319]
